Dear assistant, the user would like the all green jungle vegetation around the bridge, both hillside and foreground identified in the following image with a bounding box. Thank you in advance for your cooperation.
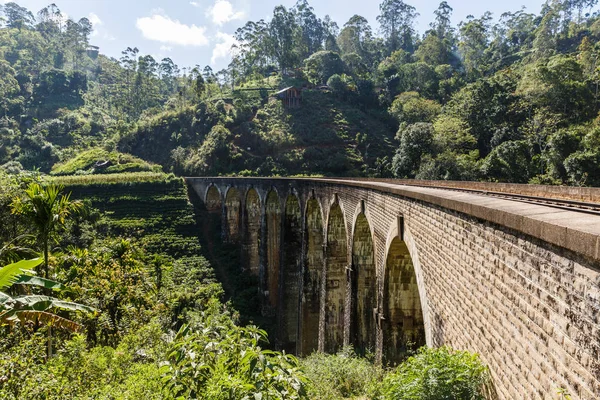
[0,0,600,400]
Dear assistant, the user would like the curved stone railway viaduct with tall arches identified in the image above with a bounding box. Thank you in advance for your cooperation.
[187,178,600,399]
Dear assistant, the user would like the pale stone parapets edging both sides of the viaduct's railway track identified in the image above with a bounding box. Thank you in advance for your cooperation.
[186,177,600,261]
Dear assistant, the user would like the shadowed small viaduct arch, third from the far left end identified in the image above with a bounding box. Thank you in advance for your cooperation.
[243,188,262,276]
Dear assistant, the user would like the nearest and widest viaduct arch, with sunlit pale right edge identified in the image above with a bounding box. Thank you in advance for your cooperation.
[378,223,432,363]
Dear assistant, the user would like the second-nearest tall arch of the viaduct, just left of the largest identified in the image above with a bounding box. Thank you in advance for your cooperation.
[350,211,377,354]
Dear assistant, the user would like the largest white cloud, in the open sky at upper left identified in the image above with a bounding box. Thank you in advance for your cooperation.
[135,13,208,46]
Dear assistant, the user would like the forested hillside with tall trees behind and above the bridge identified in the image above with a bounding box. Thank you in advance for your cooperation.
[0,0,600,185]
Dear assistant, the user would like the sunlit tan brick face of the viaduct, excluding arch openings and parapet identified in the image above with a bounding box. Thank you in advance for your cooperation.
[190,179,600,400]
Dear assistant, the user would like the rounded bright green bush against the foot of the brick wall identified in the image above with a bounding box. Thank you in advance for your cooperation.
[383,347,489,400]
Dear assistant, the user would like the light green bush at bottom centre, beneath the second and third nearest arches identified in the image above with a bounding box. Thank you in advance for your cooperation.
[301,349,384,400]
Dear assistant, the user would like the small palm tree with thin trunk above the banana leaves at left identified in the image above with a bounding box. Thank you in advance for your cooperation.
[11,183,83,278]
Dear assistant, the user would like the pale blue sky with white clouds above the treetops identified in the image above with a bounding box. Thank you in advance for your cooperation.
[0,0,556,70]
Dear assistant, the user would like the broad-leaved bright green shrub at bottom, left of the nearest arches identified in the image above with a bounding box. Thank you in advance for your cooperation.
[162,304,306,400]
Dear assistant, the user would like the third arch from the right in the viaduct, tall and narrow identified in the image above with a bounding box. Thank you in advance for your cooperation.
[324,199,348,353]
